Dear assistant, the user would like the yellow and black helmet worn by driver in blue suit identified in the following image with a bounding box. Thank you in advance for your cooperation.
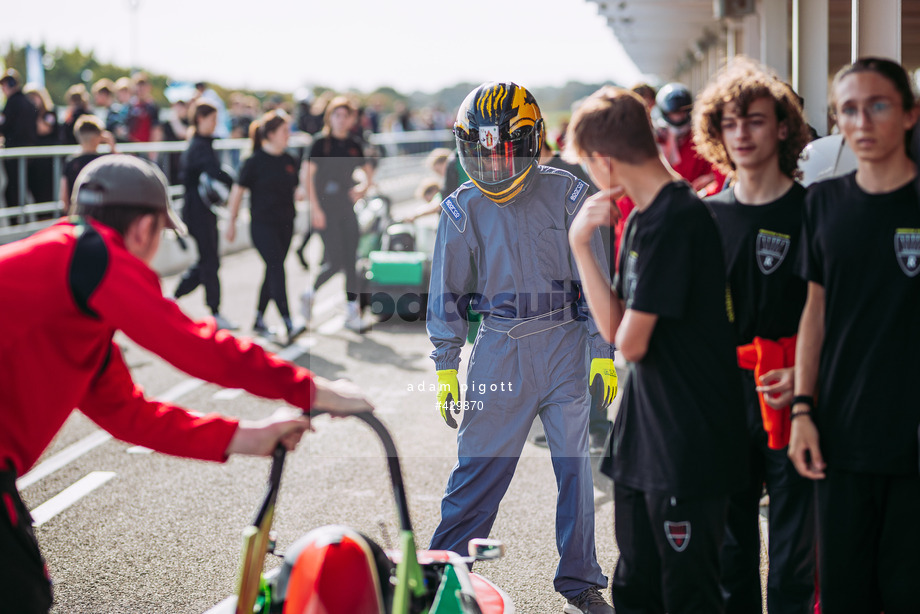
[454,82,543,204]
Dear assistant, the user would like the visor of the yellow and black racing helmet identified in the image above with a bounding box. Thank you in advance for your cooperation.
[454,126,538,185]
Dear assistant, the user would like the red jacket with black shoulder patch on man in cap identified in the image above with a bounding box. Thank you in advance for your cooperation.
[0,221,315,475]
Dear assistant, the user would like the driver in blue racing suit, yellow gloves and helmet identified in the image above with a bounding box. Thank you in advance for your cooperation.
[428,83,616,614]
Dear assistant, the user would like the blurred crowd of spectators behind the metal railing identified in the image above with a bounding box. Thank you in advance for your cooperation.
[0,69,453,217]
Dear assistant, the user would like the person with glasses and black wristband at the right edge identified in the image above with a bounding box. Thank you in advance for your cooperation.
[789,58,920,614]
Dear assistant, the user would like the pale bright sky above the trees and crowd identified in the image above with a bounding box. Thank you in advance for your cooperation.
[0,0,641,92]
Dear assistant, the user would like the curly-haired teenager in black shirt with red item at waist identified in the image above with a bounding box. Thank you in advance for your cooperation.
[694,58,815,614]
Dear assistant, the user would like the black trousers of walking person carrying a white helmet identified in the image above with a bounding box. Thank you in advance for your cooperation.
[174,203,220,313]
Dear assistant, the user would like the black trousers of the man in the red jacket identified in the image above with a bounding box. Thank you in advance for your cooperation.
[0,471,52,614]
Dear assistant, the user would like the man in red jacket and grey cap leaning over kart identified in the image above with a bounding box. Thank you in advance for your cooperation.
[0,154,371,613]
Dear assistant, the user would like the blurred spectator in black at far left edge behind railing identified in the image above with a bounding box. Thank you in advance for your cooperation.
[0,68,38,207]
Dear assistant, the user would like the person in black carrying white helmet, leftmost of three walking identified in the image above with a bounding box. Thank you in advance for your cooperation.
[173,101,239,330]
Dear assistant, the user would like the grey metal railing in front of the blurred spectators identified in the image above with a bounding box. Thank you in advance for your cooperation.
[0,130,453,244]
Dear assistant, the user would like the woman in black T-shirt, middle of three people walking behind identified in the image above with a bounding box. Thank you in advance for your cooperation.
[227,111,306,344]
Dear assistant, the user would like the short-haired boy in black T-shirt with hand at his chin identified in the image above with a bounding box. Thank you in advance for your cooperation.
[566,87,747,614]
